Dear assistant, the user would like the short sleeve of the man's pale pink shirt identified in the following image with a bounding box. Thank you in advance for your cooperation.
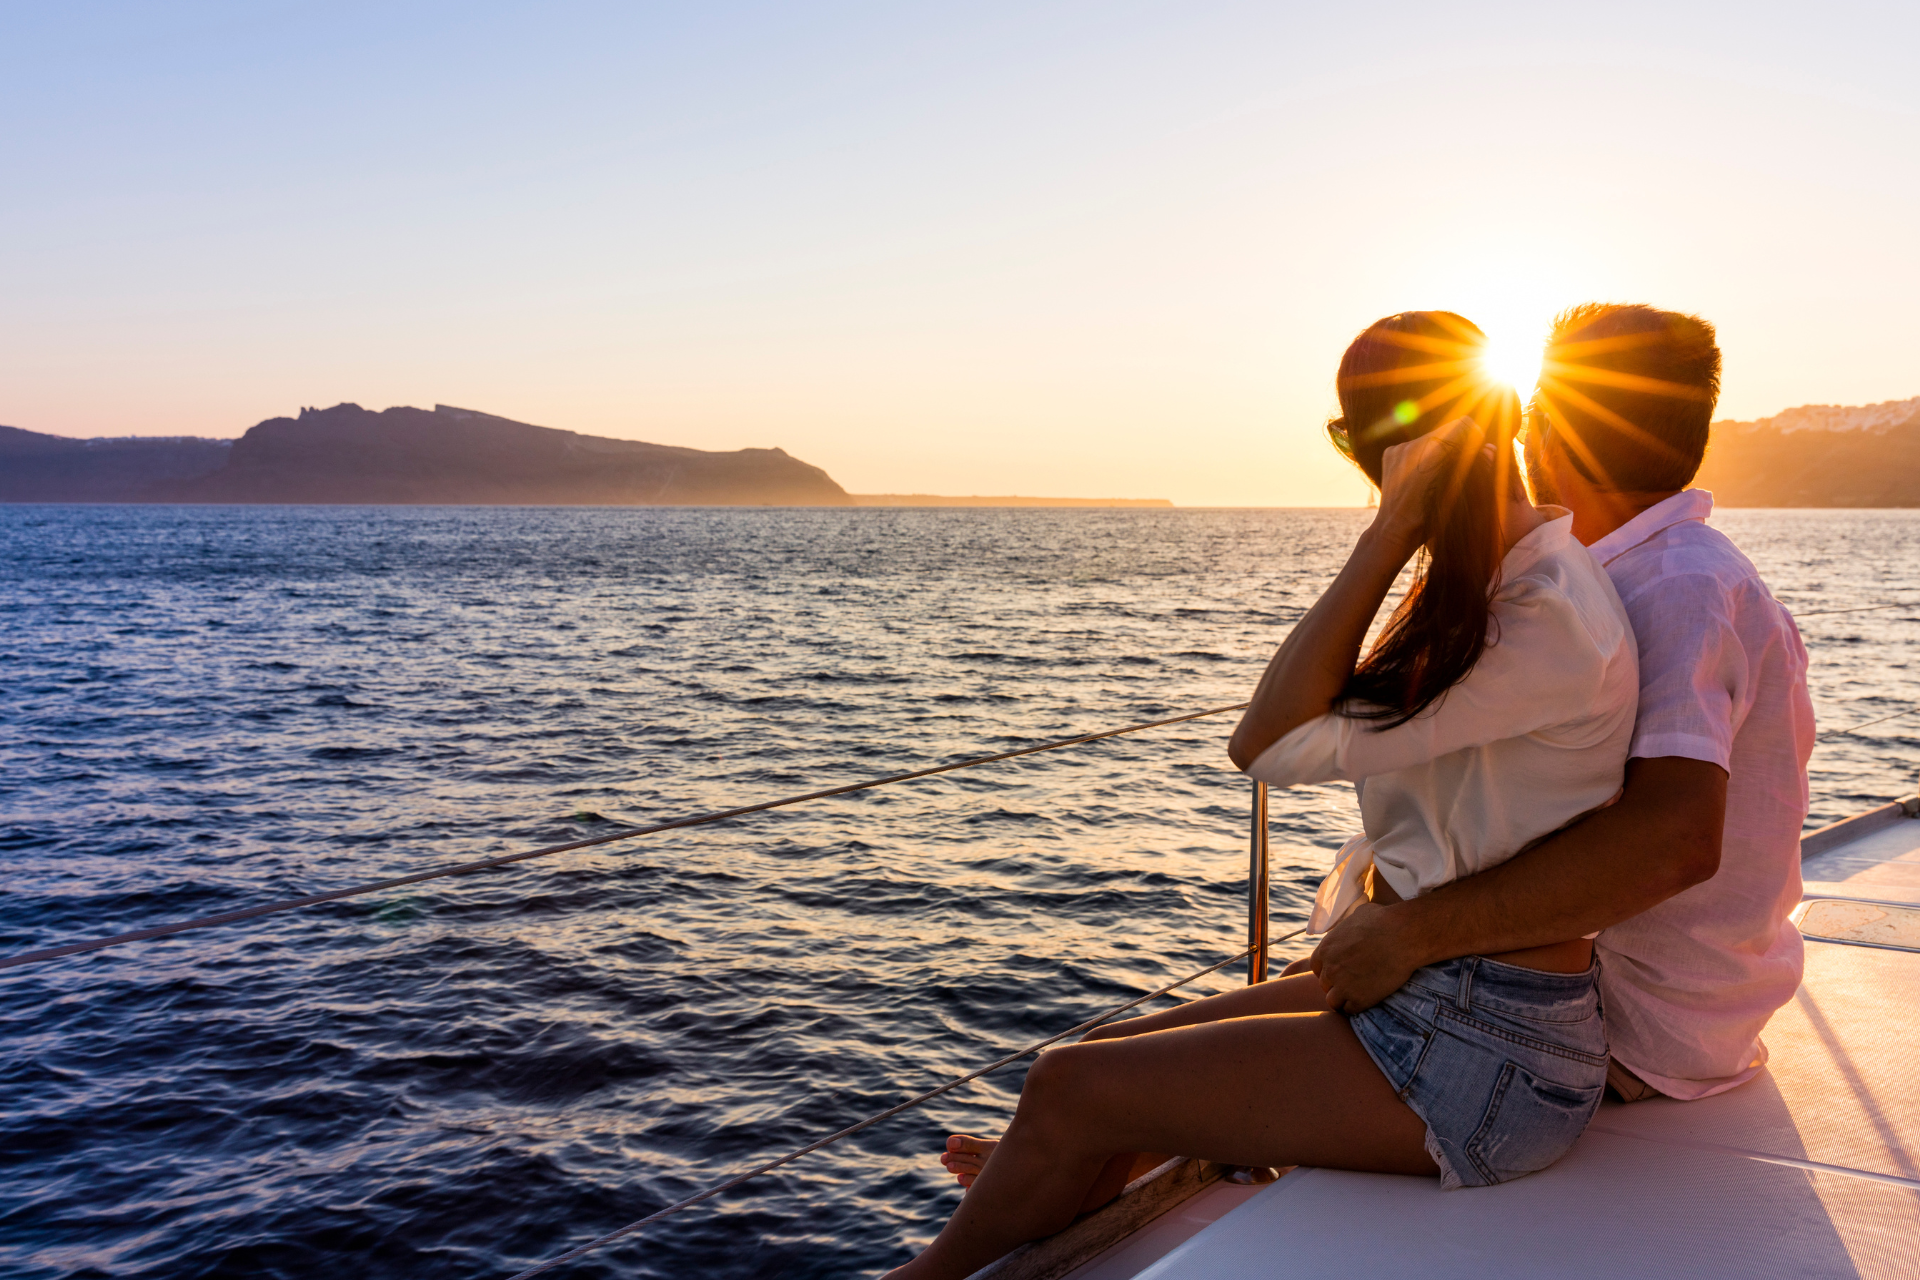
[1626,574,1751,770]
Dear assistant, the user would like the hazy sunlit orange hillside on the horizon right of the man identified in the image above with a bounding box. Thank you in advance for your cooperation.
[1693,397,1920,507]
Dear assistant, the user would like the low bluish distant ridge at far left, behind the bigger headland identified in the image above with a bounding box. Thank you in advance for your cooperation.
[0,426,232,503]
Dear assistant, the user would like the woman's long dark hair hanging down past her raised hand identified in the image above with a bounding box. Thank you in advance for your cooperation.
[1327,311,1521,729]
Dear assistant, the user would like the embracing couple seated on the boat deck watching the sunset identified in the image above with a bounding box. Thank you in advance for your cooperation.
[891,305,1812,1280]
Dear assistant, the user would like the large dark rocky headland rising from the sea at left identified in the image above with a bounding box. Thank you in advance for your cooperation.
[0,405,851,507]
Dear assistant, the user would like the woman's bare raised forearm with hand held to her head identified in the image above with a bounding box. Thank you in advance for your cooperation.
[1227,418,1478,770]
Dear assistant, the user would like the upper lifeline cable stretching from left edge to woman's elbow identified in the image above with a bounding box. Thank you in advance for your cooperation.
[0,702,1246,969]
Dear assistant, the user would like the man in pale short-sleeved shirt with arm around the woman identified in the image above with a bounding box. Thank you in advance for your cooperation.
[1308,303,1814,1102]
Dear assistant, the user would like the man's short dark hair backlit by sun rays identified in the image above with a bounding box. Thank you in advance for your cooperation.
[1528,303,1720,491]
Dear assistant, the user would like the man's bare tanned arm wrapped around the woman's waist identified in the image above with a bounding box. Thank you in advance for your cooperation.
[1311,756,1726,1013]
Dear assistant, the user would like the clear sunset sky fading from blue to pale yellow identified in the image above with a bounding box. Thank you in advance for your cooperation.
[0,0,1920,507]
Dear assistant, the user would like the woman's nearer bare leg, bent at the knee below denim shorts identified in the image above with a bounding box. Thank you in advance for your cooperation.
[893,988,1438,1280]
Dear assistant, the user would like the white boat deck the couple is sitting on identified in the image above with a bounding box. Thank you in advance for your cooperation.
[1073,794,1920,1280]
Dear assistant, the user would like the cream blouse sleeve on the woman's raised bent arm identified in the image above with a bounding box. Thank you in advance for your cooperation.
[1246,583,1624,787]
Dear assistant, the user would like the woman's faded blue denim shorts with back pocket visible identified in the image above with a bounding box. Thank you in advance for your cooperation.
[1354,956,1607,1190]
